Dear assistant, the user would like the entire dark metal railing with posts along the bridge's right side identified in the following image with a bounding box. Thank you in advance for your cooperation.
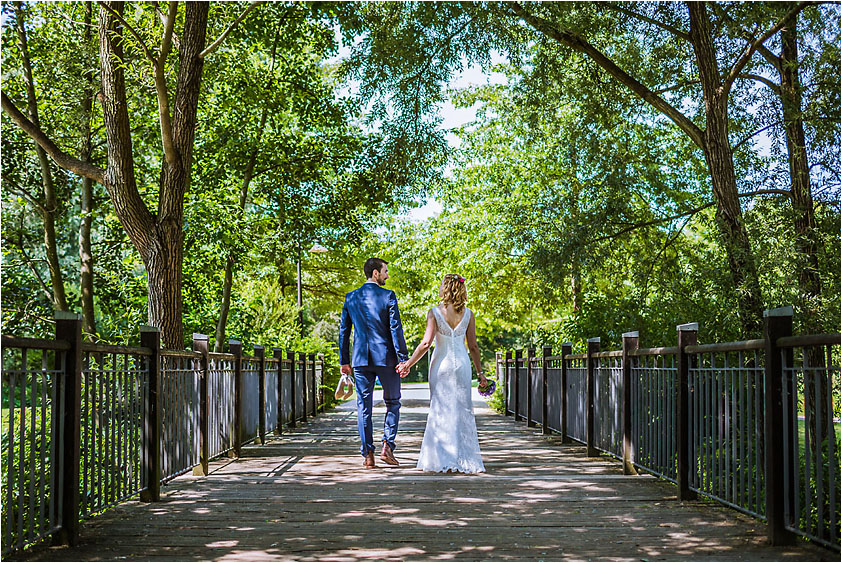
[497,307,842,550]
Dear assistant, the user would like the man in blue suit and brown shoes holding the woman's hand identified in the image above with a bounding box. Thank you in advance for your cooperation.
[339,258,408,469]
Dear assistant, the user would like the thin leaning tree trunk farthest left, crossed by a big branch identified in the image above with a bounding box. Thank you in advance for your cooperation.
[15,2,68,311]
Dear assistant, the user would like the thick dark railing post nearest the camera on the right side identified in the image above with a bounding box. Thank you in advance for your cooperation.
[763,307,793,545]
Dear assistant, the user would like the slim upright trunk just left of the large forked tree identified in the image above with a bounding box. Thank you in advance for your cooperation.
[79,2,96,340]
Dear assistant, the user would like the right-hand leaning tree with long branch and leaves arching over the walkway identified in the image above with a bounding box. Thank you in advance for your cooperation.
[334,2,828,335]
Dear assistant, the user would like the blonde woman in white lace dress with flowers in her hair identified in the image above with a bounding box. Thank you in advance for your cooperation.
[397,274,488,473]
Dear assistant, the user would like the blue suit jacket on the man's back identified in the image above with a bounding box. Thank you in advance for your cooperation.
[339,283,409,367]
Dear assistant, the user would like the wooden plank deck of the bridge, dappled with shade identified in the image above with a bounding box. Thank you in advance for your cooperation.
[16,385,839,561]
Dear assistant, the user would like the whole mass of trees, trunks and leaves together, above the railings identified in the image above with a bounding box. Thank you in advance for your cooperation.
[2,2,840,366]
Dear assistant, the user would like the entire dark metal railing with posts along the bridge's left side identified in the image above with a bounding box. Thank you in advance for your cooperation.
[0,313,324,556]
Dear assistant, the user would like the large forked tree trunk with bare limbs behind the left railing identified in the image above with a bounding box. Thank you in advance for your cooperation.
[2,2,256,348]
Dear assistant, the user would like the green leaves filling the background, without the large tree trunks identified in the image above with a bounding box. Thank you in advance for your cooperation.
[2,2,842,374]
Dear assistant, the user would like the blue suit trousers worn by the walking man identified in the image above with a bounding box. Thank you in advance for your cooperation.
[354,366,401,456]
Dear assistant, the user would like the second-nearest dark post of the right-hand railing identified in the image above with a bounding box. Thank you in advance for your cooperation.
[675,323,699,500]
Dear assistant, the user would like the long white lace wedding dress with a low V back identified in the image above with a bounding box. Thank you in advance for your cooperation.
[417,307,485,473]
